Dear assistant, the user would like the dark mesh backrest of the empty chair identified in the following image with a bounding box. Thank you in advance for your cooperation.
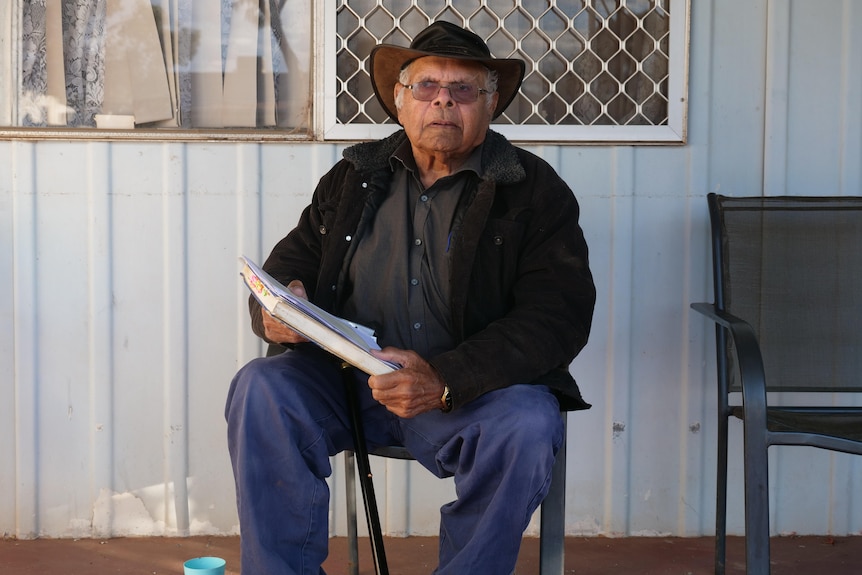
[708,194,862,392]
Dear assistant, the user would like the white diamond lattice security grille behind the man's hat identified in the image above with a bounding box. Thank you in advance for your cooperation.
[336,0,670,126]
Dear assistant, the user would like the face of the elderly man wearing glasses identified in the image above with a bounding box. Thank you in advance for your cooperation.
[395,56,498,161]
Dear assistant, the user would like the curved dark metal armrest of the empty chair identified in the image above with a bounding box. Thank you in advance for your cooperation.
[691,302,766,428]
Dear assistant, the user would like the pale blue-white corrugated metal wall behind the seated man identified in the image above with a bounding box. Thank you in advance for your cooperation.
[5,0,862,537]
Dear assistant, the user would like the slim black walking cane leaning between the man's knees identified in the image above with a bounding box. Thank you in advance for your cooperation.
[341,363,389,575]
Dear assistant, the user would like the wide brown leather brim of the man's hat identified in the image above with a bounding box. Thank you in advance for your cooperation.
[369,44,526,124]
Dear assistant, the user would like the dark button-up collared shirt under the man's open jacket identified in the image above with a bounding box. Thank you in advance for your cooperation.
[344,141,481,359]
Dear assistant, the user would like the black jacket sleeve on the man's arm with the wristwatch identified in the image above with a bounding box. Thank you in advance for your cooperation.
[430,154,596,408]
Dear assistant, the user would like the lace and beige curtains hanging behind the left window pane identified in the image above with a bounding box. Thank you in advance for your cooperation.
[11,0,311,129]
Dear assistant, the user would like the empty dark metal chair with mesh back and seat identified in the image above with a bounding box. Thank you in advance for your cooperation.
[692,194,862,574]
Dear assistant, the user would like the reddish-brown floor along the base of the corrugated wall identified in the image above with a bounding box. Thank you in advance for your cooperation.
[0,536,862,575]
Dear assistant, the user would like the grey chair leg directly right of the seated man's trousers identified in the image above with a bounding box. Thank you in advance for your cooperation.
[539,412,568,575]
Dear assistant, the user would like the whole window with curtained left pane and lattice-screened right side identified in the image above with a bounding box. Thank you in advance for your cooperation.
[0,0,690,143]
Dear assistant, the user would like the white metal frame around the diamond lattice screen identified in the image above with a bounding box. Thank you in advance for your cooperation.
[314,0,691,144]
